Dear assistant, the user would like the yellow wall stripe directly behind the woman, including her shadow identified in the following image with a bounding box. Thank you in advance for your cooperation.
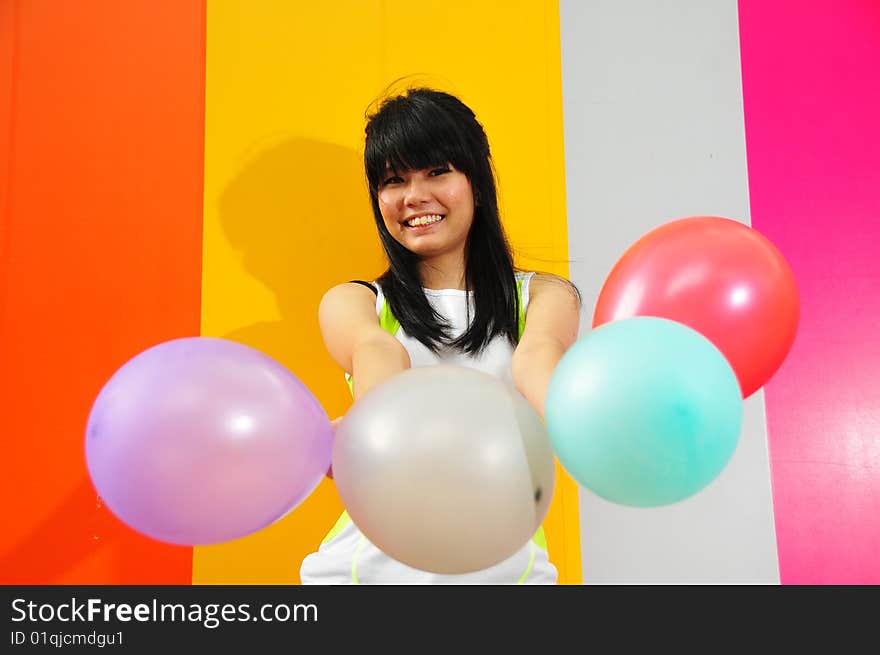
[193,0,581,584]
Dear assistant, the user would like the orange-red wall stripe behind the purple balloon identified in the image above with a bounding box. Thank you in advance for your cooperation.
[0,0,205,584]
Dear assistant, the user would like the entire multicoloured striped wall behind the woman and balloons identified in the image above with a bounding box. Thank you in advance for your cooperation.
[0,0,880,584]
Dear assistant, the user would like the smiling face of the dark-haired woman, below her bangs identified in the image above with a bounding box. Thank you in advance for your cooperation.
[377,164,474,259]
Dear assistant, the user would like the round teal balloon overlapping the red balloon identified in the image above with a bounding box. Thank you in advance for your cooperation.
[545,317,743,507]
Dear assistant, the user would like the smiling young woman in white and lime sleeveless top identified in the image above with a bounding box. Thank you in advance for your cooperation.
[300,89,580,584]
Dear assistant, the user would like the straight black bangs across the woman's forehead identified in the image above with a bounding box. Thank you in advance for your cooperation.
[364,101,476,193]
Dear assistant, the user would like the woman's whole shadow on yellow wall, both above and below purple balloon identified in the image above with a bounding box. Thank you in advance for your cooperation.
[205,139,386,584]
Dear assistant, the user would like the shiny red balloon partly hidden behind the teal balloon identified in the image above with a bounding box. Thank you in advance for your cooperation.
[593,216,800,398]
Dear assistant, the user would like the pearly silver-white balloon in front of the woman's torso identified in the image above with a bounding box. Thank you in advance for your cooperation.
[333,365,555,573]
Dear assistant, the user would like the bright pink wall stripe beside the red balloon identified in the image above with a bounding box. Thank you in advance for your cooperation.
[739,0,880,584]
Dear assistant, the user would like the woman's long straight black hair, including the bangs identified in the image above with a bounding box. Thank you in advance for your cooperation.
[364,88,519,354]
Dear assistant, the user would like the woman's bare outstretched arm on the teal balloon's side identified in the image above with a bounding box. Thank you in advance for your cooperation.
[511,274,581,418]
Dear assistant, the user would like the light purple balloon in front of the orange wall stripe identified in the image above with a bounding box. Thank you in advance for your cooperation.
[86,337,333,546]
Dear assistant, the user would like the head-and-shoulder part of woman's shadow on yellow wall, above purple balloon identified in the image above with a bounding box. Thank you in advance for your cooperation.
[219,140,385,413]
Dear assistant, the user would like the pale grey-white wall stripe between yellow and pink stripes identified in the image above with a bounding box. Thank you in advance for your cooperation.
[560,0,779,584]
